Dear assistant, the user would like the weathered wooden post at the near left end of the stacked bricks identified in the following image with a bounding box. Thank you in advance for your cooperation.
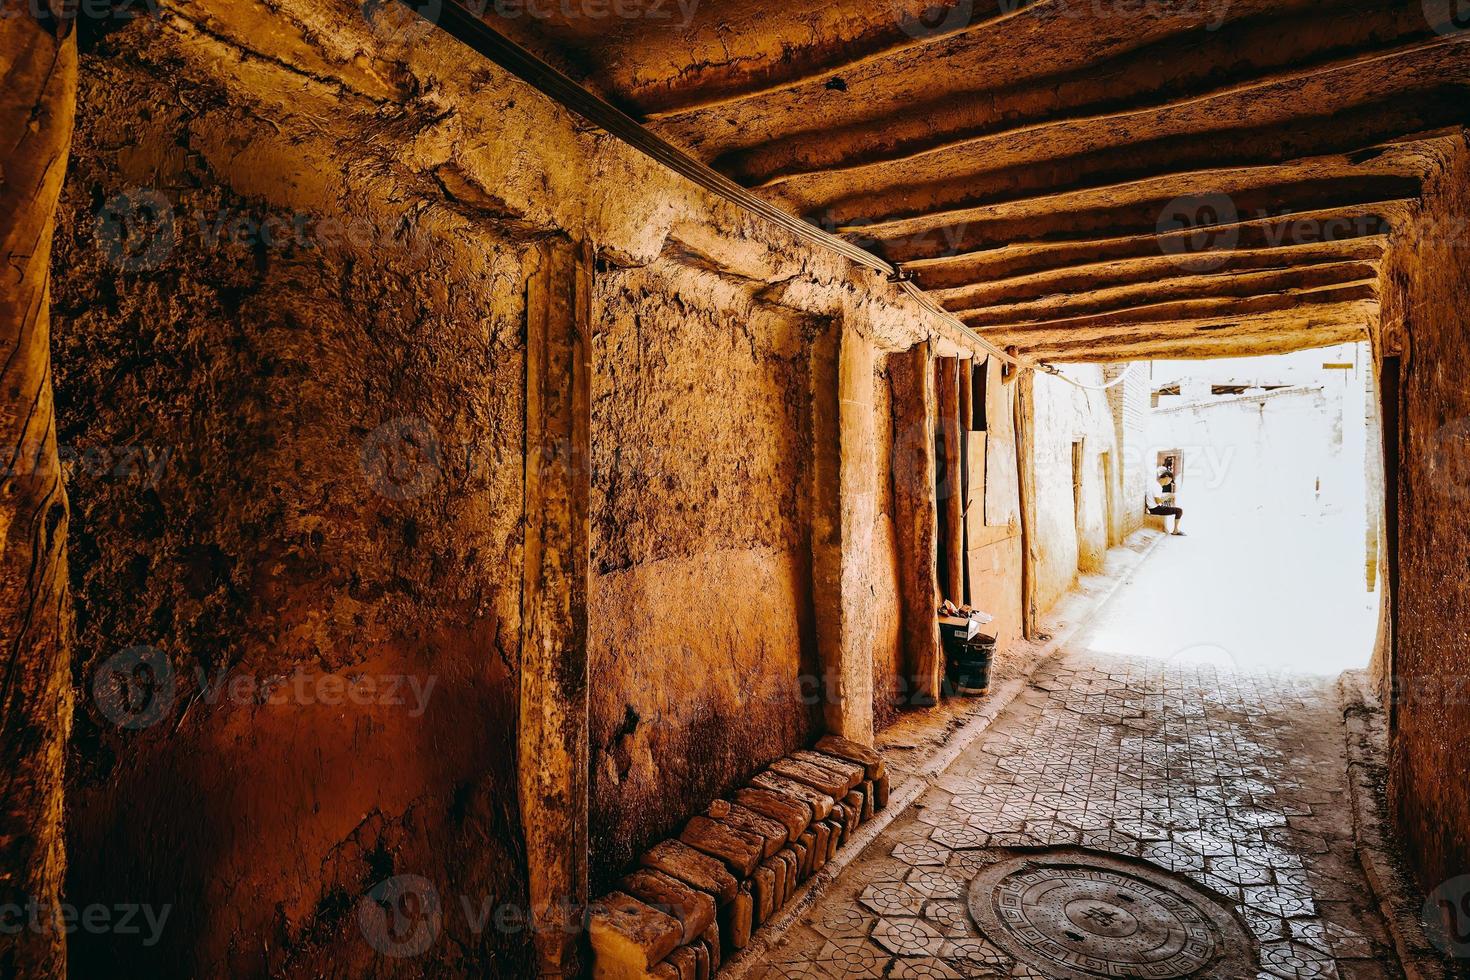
[517,241,592,977]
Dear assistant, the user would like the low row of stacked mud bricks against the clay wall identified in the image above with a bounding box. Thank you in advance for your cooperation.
[588,736,888,980]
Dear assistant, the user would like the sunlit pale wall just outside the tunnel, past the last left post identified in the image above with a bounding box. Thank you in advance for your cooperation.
[1035,364,1117,611]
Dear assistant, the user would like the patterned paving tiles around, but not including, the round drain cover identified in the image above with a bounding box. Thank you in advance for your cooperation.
[751,654,1398,980]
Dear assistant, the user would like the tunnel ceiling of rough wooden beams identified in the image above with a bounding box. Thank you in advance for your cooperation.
[488,0,1470,360]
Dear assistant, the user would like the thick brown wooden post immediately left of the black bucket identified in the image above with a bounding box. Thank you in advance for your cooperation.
[888,344,944,704]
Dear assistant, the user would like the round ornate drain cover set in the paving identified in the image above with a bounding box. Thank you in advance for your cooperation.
[970,851,1257,980]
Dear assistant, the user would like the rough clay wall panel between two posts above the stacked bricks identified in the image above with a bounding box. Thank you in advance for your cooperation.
[589,267,820,892]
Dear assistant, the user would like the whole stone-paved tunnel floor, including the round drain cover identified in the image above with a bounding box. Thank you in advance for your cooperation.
[747,646,1401,980]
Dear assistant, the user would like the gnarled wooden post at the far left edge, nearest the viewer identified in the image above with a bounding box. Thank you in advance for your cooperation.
[0,11,76,980]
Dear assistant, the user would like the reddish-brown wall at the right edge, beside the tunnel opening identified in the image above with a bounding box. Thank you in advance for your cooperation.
[1383,135,1470,889]
